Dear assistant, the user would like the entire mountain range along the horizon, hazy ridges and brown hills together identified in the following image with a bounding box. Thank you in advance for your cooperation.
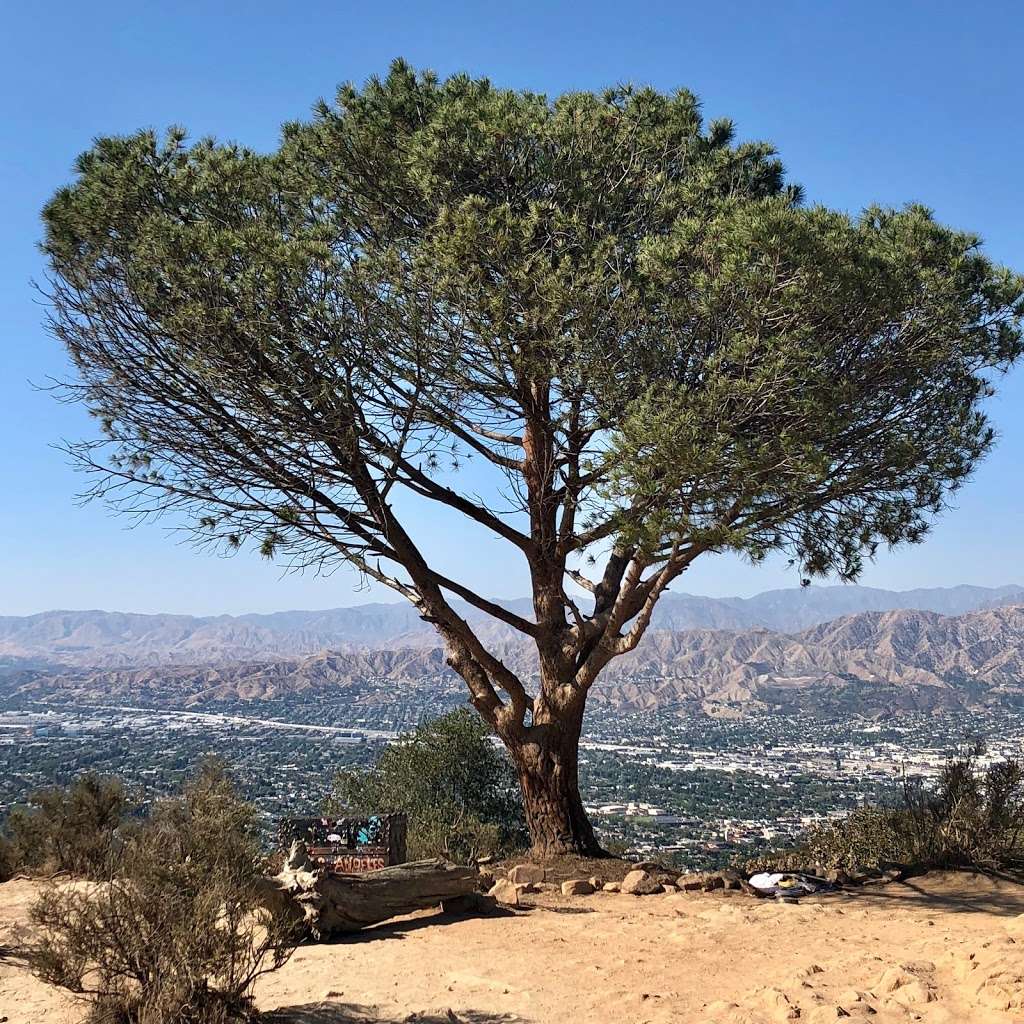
[0,587,1024,714]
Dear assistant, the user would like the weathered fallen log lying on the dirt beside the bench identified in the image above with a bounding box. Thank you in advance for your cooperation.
[272,843,478,940]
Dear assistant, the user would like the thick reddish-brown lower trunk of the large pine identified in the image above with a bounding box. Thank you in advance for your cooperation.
[508,711,606,859]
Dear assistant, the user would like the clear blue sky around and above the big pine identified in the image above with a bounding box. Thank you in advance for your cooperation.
[0,0,1024,614]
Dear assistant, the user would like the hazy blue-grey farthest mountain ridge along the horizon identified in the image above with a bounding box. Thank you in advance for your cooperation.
[0,586,1024,672]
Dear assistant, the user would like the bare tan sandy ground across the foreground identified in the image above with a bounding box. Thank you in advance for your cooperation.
[0,874,1024,1024]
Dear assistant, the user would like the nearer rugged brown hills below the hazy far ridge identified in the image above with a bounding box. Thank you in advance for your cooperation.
[12,603,1024,715]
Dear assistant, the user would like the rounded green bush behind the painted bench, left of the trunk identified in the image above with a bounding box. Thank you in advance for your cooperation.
[326,709,527,862]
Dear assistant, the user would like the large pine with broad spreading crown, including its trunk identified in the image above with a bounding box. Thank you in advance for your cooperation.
[44,61,1024,853]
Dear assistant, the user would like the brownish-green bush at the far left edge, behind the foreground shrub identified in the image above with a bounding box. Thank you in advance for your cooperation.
[3,772,132,879]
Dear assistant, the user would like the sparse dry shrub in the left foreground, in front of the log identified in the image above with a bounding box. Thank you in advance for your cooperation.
[28,763,298,1024]
